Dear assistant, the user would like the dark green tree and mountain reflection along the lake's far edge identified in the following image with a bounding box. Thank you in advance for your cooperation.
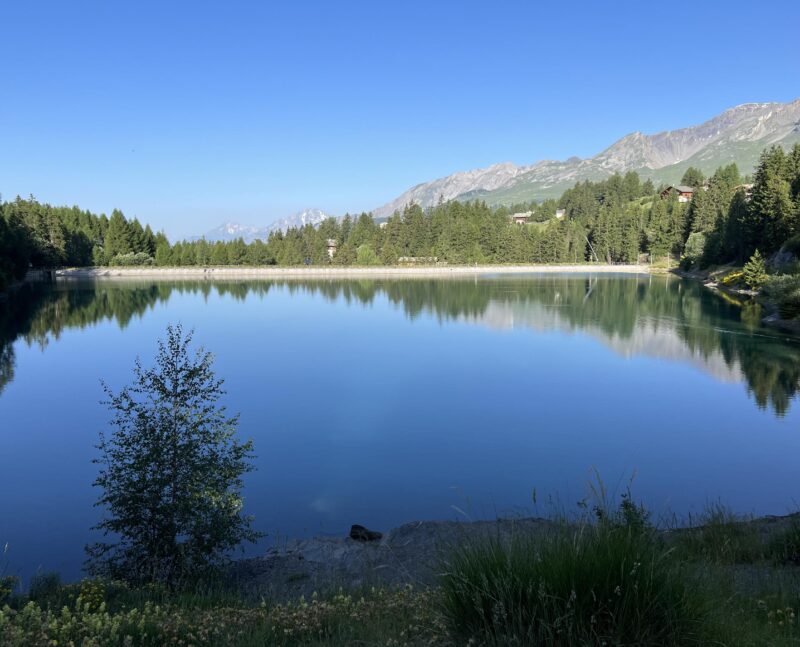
[0,275,800,416]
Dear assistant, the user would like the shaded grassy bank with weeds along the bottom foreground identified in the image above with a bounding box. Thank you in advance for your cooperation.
[0,498,800,646]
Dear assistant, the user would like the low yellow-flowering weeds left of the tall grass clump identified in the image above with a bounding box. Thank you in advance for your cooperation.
[0,580,445,647]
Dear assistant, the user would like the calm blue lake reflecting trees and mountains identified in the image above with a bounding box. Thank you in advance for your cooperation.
[0,274,800,579]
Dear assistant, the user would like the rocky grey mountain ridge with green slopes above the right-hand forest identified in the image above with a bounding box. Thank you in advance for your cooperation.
[373,99,800,218]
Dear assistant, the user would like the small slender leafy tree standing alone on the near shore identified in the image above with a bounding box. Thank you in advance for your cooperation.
[87,325,260,586]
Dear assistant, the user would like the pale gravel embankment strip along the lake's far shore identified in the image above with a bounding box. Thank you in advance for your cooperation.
[56,264,650,279]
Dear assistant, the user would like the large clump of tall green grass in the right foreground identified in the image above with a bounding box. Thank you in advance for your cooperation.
[442,500,707,645]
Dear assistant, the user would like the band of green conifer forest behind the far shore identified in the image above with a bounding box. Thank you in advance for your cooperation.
[0,145,800,287]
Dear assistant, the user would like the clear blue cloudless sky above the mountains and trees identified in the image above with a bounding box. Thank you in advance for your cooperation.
[0,0,800,237]
